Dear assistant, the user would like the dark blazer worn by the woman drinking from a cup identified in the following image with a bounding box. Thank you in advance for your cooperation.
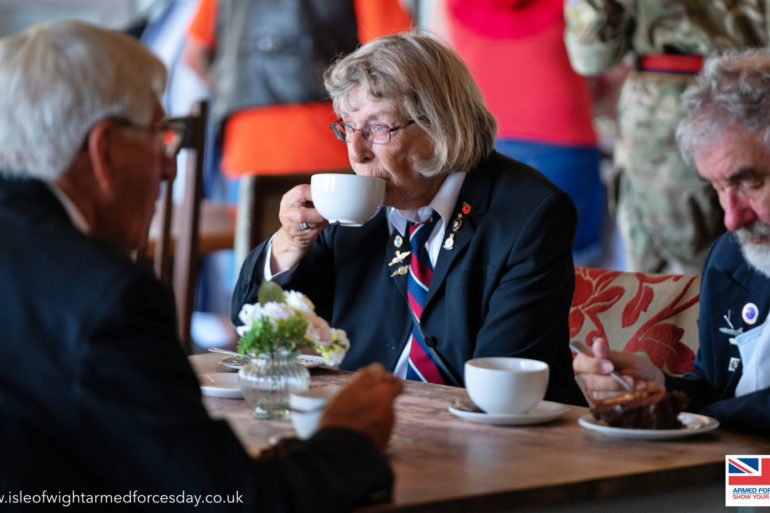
[232,153,583,404]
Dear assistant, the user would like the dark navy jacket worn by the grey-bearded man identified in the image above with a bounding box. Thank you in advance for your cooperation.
[666,232,770,435]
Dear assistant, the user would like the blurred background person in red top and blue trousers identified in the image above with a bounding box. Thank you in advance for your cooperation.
[445,0,605,266]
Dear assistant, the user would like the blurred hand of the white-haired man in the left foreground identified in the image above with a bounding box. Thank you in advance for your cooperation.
[320,363,403,450]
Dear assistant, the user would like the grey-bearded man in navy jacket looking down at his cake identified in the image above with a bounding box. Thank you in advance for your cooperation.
[573,49,770,435]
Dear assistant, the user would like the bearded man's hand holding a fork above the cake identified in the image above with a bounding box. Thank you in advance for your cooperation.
[572,338,665,400]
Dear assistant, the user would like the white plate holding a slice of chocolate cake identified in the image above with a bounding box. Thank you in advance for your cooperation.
[578,388,719,440]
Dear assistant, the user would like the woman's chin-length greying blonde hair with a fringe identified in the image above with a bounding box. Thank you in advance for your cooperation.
[324,32,497,176]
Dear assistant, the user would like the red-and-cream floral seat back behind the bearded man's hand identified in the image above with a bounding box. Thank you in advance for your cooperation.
[569,267,700,374]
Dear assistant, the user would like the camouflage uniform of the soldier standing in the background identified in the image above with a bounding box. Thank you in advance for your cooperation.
[565,0,770,274]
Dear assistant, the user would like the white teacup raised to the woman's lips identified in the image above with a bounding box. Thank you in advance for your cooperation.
[310,173,385,226]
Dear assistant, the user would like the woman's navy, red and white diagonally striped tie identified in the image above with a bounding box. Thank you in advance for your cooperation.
[406,211,444,384]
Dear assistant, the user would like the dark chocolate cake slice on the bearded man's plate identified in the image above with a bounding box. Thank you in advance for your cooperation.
[591,388,687,429]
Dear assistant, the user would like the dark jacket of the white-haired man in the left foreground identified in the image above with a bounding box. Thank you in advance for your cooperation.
[0,178,392,512]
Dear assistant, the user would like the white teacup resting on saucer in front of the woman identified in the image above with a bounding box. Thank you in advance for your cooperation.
[465,356,548,415]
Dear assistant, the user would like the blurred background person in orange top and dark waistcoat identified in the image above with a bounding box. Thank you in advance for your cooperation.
[184,0,411,261]
